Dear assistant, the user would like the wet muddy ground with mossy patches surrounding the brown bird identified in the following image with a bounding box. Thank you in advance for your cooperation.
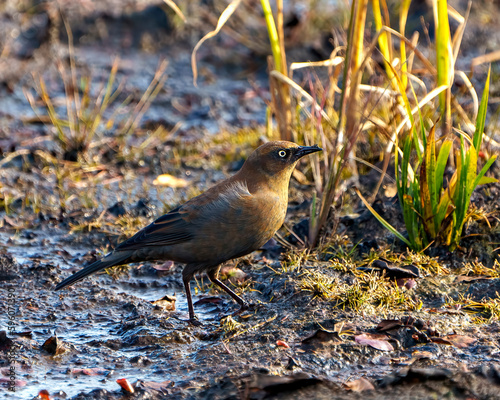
[0,1,500,399]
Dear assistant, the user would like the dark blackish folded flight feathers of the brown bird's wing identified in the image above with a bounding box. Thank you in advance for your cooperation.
[115,206,193,251]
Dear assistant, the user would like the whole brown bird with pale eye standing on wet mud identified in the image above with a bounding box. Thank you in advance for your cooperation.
[55,141,321,324]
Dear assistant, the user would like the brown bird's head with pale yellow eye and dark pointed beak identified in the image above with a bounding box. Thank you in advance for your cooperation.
[242,141,322,184]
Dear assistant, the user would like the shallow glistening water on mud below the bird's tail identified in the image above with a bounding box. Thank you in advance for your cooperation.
[0,227,222,399]
